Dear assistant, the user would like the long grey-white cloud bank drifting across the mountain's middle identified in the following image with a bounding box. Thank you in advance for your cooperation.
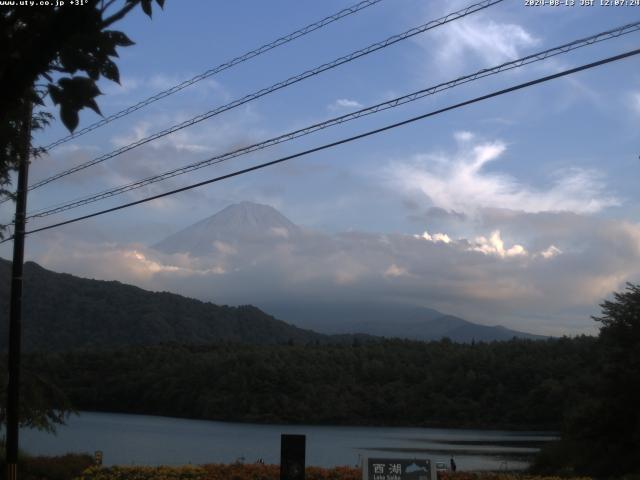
[18,203,640,334]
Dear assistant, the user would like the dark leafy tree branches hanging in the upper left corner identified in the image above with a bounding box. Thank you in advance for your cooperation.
[0,0,164,209]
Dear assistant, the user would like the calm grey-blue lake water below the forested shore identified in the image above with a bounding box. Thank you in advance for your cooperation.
[20,412,554,470]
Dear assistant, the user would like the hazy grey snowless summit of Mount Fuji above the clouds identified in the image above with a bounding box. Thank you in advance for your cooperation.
[153,201,301,256]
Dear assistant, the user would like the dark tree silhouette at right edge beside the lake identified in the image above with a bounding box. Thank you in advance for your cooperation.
[539,284,640,477]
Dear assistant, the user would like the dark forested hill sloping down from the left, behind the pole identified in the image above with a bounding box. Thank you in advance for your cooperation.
[0,259,364,351]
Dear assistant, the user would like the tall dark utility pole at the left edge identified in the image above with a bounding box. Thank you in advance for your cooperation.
[6,99,33,480]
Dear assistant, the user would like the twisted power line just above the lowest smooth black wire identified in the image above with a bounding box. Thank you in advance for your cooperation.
[27,22,640,219]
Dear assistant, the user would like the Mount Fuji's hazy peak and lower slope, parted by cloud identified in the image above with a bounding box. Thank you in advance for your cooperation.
[152,202,545,342]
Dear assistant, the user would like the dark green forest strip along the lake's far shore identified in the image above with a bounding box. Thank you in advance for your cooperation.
[20,337,595,429]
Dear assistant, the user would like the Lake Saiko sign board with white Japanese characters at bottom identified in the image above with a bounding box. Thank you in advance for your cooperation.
[362,458,437,480]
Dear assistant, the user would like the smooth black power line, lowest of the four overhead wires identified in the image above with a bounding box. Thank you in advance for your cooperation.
[7,49,640,243]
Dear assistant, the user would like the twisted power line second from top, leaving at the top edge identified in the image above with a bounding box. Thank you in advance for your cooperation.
[29,0,504,194]
